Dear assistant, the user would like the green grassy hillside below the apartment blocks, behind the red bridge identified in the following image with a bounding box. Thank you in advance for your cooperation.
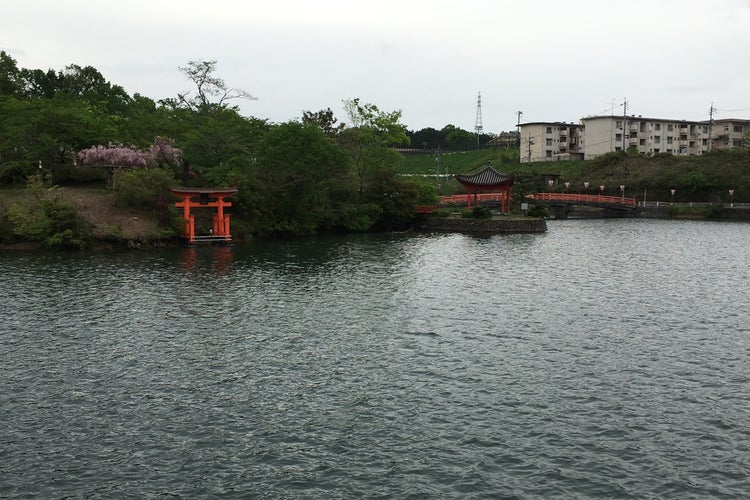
[400,149,750,203]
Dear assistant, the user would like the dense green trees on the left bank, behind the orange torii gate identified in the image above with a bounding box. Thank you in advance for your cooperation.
[0,52,440,235]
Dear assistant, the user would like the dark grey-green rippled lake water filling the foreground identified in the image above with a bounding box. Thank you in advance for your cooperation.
[0,220,750,498]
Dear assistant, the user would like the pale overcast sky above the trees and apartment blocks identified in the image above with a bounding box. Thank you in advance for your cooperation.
[0,0,750,133]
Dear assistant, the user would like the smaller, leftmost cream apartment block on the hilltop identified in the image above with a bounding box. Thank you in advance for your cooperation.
[520,122,583,163]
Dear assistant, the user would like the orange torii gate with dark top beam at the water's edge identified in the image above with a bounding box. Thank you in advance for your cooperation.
[170,187,237,243]
